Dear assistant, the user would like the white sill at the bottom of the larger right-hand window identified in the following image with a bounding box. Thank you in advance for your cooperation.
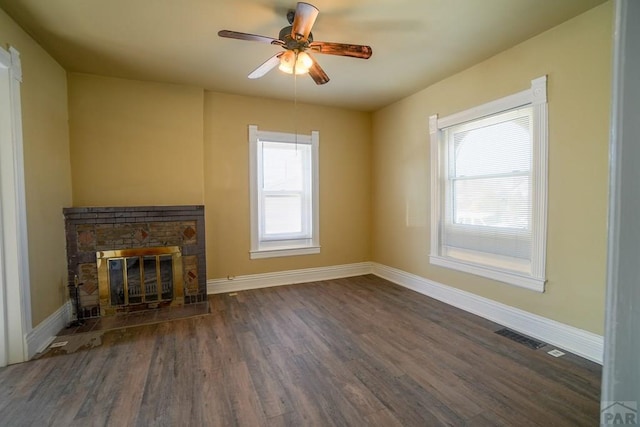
[429,255,546,292]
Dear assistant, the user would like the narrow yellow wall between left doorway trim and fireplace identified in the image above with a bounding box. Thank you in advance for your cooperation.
[0,10,71,326]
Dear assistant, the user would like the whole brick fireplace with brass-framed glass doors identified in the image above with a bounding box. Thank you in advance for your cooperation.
[63,205,207,318]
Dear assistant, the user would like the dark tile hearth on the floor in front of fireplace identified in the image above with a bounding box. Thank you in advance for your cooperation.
[57,302,210,337]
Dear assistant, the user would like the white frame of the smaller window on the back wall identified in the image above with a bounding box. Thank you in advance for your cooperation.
[249,125,320,259]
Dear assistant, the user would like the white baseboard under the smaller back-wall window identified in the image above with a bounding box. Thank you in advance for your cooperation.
[207,262,372,294]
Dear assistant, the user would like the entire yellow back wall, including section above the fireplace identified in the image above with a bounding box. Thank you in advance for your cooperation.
[69,79,371,279]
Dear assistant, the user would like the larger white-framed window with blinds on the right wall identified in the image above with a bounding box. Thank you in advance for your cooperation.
[429,76,547,291]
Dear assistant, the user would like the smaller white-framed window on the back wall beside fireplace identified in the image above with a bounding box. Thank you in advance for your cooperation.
[249,126,320,259]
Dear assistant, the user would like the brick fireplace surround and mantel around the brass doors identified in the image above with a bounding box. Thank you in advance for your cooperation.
[63,205,207,318]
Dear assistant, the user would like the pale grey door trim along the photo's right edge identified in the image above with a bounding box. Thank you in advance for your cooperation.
[601,0,640,410]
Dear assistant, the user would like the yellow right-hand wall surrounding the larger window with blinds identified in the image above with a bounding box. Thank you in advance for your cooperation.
[372,2,612,334]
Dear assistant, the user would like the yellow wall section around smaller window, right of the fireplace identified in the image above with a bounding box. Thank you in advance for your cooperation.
[205,92,371,278]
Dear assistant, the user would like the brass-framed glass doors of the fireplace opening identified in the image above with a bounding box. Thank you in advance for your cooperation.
[96,246,184,316]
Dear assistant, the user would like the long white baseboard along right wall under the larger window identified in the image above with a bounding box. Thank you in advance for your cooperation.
[373,263,604,364]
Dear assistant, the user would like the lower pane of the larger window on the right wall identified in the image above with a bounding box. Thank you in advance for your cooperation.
[453,176,531,230]
